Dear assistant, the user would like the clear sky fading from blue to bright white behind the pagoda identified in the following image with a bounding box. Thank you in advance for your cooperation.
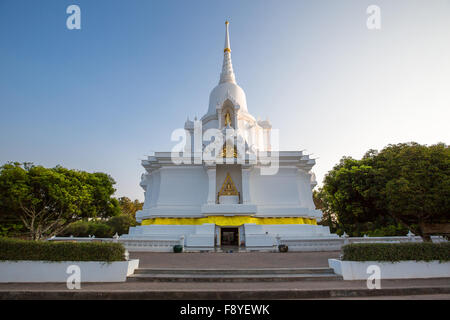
[0,0,450,200]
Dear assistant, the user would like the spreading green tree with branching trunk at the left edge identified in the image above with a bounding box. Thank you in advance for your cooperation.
[0,163,120,240]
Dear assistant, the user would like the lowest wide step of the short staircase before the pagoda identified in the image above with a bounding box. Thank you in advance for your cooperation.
[127,273,342,282]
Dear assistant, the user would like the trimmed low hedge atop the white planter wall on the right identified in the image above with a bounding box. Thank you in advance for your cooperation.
[342,242,450,262]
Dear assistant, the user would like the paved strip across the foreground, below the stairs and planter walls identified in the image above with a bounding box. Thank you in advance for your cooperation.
[0,279,450,300]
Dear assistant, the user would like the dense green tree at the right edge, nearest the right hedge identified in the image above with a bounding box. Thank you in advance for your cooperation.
[365,143,450,241]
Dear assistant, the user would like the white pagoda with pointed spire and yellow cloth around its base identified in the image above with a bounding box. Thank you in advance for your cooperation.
[121,22,336,251]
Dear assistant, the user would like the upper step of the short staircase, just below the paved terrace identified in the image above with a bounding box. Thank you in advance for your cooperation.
[134,268,333,275]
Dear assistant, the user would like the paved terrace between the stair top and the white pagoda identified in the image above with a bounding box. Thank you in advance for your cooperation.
[130,251,340,269]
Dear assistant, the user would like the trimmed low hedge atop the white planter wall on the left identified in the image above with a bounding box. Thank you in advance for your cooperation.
[0,238,125,262]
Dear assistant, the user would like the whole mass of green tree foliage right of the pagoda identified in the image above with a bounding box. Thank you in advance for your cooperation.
[316,142,450,240]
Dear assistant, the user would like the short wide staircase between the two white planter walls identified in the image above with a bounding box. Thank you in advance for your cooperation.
[127,268,342,282]
